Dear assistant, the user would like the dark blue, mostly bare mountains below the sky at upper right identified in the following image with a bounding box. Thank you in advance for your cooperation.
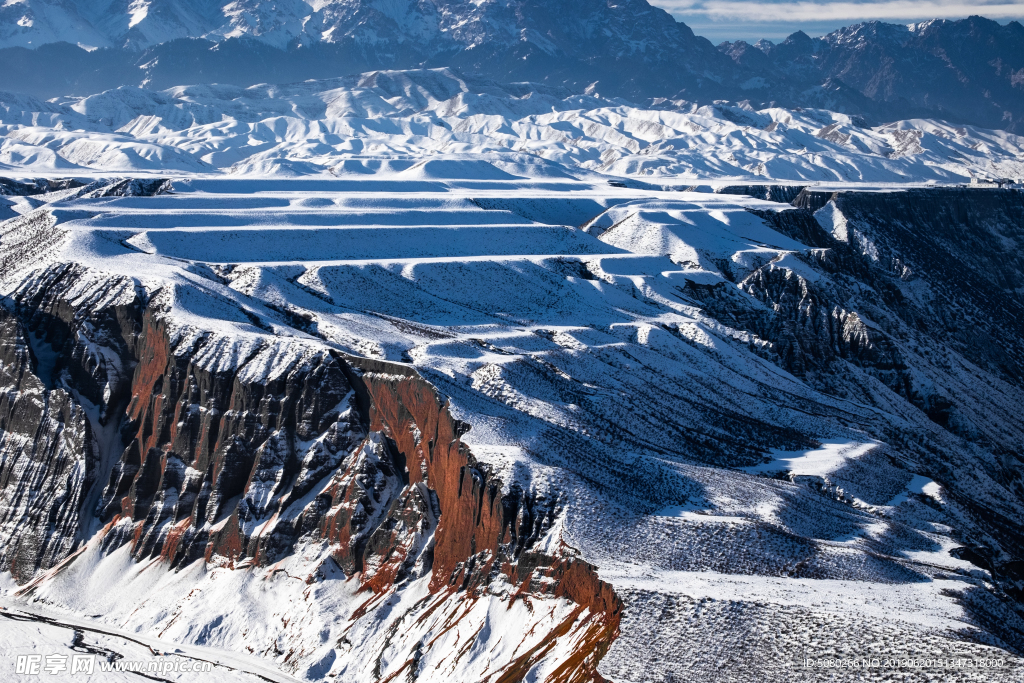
[719,16,1024,132]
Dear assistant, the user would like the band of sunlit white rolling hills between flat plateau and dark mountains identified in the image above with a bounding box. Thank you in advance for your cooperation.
[0,70,1024,185]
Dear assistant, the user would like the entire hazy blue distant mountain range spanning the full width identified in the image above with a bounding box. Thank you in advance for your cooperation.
[0,0,1024,132]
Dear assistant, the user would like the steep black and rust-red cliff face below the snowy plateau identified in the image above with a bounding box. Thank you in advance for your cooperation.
[0,260,622,680]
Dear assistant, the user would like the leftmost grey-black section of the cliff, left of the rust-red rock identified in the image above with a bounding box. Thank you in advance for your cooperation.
[0,267,138,581]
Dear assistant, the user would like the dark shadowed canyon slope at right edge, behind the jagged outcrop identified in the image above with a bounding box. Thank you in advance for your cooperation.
[819,187,1024,384]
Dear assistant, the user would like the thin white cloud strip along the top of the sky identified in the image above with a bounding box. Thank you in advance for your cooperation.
[655,0,1024,24]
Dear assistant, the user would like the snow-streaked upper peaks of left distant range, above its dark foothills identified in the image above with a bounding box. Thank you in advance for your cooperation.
[0,0,720,57]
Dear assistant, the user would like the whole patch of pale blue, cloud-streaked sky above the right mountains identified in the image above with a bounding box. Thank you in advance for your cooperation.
[650,0,1024,45]
